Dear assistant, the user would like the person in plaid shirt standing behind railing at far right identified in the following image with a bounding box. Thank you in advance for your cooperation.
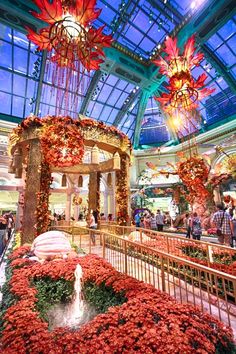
[212,204,234,246]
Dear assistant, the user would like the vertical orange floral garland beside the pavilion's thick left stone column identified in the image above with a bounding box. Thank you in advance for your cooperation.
[35,161,53,236]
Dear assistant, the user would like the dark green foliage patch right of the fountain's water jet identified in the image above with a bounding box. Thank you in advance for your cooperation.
[83,282,127,313]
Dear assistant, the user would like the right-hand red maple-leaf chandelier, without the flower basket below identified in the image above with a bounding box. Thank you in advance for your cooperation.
[153,36,215,114]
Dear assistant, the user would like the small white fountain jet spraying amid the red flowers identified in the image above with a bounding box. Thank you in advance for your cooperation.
[48,264,97,329]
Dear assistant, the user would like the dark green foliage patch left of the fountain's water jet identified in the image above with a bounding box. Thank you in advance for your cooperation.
[33,277,74,321]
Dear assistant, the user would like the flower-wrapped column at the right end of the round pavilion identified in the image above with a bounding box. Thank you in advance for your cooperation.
[116,154,130,225]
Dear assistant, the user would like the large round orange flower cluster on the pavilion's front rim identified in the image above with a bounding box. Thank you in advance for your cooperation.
[40,117,84,167]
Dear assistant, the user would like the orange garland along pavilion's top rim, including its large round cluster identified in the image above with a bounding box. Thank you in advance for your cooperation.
[9,116,131,167]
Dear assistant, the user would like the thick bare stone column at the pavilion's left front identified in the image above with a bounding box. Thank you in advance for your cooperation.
[21,139,42,244]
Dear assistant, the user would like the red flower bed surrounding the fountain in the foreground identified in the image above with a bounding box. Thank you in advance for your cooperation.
[1,247,234,354]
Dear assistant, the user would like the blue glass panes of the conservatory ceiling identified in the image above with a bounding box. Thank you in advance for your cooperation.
[0,0,236,146]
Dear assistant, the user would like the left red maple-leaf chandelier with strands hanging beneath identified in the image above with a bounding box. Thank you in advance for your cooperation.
[26,0,112,114]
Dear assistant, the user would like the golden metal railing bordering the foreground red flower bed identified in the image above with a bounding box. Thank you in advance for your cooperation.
[51,227,236,327]
